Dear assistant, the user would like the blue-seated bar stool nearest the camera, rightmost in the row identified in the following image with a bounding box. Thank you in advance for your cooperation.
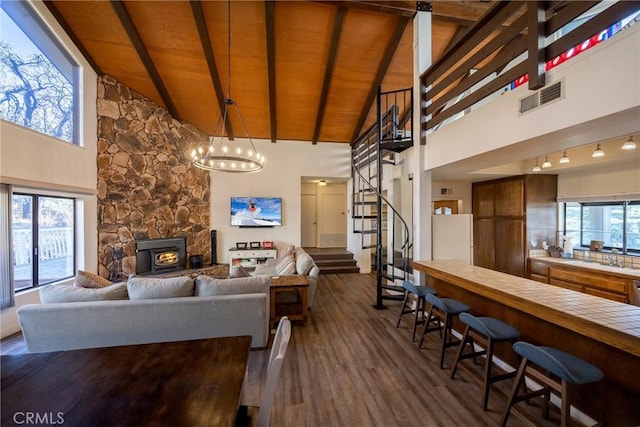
[500,341,604,427]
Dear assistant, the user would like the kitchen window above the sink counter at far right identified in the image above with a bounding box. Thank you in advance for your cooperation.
[564,201,640,254]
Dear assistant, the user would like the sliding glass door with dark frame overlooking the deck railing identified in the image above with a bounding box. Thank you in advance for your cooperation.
[11,193,75,292]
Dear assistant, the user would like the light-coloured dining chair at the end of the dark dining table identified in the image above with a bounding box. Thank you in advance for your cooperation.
[235,316,291,427]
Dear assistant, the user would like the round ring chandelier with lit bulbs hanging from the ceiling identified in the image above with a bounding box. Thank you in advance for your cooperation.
[191,0,265,173]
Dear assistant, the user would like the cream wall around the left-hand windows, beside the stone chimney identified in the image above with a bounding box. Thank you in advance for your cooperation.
[0,1,98,337]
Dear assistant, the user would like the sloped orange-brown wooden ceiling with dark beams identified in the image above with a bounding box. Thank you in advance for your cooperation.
[46,0,492,143]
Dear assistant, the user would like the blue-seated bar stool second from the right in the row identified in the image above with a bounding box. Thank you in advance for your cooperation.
[451,313,520,411]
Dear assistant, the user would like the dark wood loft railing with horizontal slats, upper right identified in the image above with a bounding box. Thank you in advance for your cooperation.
[420,1,640,138]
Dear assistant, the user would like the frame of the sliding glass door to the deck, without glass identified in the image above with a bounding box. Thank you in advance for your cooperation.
[11,191,78,294]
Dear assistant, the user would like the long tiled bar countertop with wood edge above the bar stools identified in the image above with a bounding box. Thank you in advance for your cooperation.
[413,258,640,357]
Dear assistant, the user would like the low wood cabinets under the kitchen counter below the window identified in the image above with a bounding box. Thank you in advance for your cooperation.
[527,258,637,304]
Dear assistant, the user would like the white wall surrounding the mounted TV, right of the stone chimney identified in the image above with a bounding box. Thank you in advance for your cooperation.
[211,141,351,263]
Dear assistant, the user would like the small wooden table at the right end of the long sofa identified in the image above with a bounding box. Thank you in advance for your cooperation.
[269,274,309,324]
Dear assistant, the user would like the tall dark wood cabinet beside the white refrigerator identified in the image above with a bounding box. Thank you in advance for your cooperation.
[472,174,558,277]
